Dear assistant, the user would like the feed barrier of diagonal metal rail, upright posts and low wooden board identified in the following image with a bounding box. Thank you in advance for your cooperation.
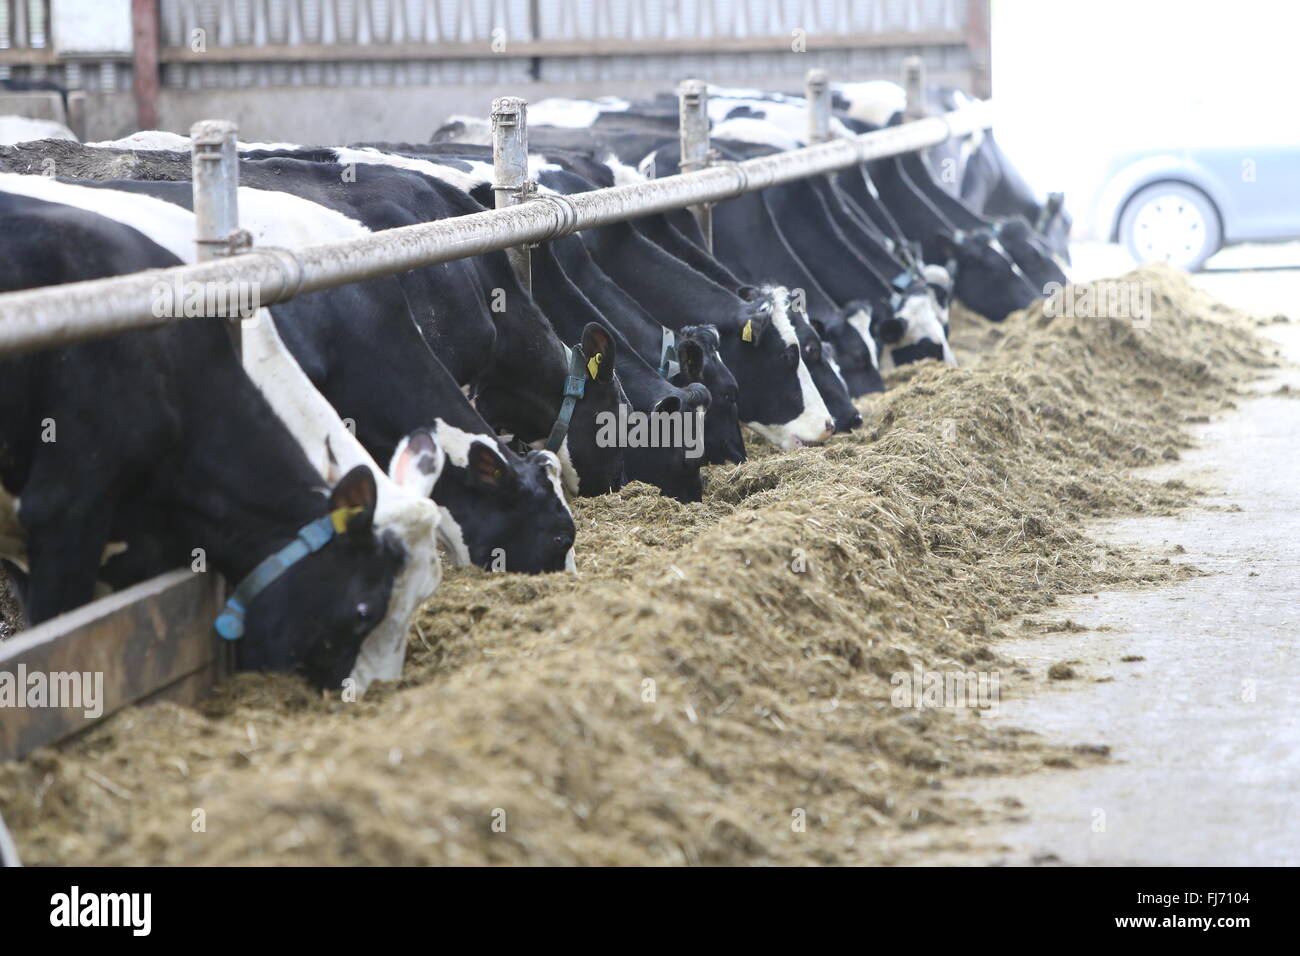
[0,62,988,760]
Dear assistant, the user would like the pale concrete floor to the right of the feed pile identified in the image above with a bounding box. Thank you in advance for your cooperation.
[906,260,1300,865]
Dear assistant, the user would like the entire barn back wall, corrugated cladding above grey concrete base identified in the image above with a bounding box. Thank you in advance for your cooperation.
[0,0,988,142]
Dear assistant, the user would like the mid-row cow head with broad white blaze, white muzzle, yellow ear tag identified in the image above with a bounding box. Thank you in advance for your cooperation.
[718,286,835,449]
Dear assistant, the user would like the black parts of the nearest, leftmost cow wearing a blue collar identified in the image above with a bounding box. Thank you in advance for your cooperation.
[0,177,406,687]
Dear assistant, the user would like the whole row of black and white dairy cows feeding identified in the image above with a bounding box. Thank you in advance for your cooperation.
[0,85,1069,689]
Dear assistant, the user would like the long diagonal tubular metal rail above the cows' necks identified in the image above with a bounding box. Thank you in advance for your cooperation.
[0,92,987,354]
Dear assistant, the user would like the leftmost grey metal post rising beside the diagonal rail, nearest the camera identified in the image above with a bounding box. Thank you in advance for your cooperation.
[190,120,248,358]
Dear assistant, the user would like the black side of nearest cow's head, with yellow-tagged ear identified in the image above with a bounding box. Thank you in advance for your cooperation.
[235,464,406,688]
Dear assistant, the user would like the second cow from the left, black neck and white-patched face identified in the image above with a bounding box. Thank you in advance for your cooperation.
[38,160,575,572]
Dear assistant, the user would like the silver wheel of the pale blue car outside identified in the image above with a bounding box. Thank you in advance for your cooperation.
[1119,182,1223,272]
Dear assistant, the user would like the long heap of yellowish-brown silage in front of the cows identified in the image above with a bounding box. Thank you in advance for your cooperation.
[0,268,1273,864]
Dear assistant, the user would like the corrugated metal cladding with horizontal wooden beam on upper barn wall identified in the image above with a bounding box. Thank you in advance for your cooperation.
[0,0,972,91]
